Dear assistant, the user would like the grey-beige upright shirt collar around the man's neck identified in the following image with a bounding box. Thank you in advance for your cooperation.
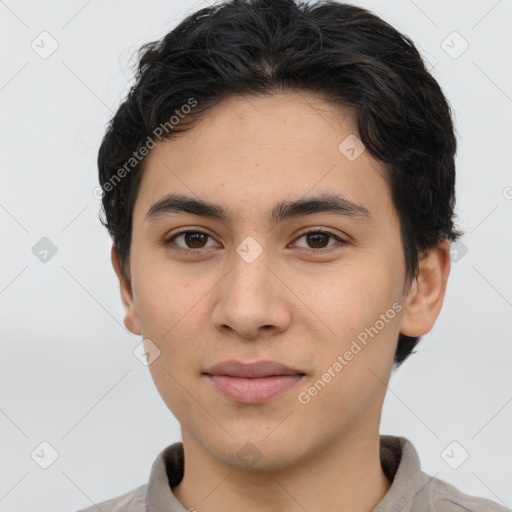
[146,435,429,512]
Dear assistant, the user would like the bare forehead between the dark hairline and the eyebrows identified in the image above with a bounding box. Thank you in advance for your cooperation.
[136,92,390,224]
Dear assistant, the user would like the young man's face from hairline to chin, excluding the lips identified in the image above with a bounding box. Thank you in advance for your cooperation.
[119,93,428,469]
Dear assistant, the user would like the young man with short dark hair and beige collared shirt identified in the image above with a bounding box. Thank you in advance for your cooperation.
[82,0,505,512]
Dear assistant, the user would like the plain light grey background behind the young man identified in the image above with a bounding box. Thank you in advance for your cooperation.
[0,0,512,512]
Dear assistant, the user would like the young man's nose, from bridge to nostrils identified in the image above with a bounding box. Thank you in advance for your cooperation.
[212,250,291,339]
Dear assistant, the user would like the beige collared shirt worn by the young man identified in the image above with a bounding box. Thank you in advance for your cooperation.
[79,435,510,512]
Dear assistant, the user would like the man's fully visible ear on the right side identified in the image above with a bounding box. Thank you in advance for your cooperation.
[400,238,450,337]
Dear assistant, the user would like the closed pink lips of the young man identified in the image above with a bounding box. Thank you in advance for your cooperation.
[203,360,306,404]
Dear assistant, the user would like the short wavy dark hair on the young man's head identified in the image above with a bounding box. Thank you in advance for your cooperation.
[98,0,462,367]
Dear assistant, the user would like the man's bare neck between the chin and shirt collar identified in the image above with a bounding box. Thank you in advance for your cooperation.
[172,431,391,512]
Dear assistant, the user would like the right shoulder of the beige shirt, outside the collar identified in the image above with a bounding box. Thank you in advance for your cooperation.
[420,473,509,512]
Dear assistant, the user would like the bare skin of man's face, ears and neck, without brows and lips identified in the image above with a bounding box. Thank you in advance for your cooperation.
[112,93,450,512]
